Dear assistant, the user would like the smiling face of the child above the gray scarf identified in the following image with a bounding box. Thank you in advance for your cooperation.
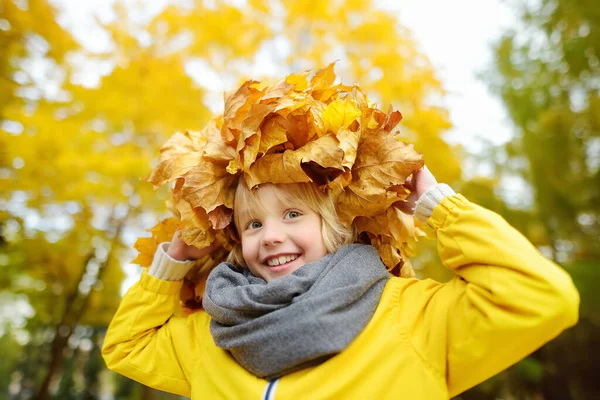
[239,185,327,282]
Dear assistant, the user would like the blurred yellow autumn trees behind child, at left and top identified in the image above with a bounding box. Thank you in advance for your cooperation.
[0,0,460,399]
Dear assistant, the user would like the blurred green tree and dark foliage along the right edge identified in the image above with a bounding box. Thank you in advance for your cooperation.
[468,0,600,399]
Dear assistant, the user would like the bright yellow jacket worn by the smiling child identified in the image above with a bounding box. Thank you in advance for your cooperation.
[102,195,579,400]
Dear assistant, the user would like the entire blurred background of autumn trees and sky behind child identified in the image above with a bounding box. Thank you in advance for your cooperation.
[0,0,600,399]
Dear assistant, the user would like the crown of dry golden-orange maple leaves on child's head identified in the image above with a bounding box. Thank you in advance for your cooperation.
[134,64,424,305]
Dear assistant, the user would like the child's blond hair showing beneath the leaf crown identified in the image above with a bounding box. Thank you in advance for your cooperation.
[227,177,356,267]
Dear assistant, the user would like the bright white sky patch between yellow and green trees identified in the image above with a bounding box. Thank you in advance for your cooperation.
[381,0,517,151]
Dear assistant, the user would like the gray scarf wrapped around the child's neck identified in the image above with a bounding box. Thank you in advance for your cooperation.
[203,244,390,379]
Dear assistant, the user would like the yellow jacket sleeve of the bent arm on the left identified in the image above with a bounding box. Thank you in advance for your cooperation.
[102,271,208,397]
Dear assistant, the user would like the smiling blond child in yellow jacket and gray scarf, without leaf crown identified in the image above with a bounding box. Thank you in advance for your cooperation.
[102,168,579,399]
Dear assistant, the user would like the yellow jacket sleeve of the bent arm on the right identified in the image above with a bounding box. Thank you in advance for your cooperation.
[403,194,579,397]
